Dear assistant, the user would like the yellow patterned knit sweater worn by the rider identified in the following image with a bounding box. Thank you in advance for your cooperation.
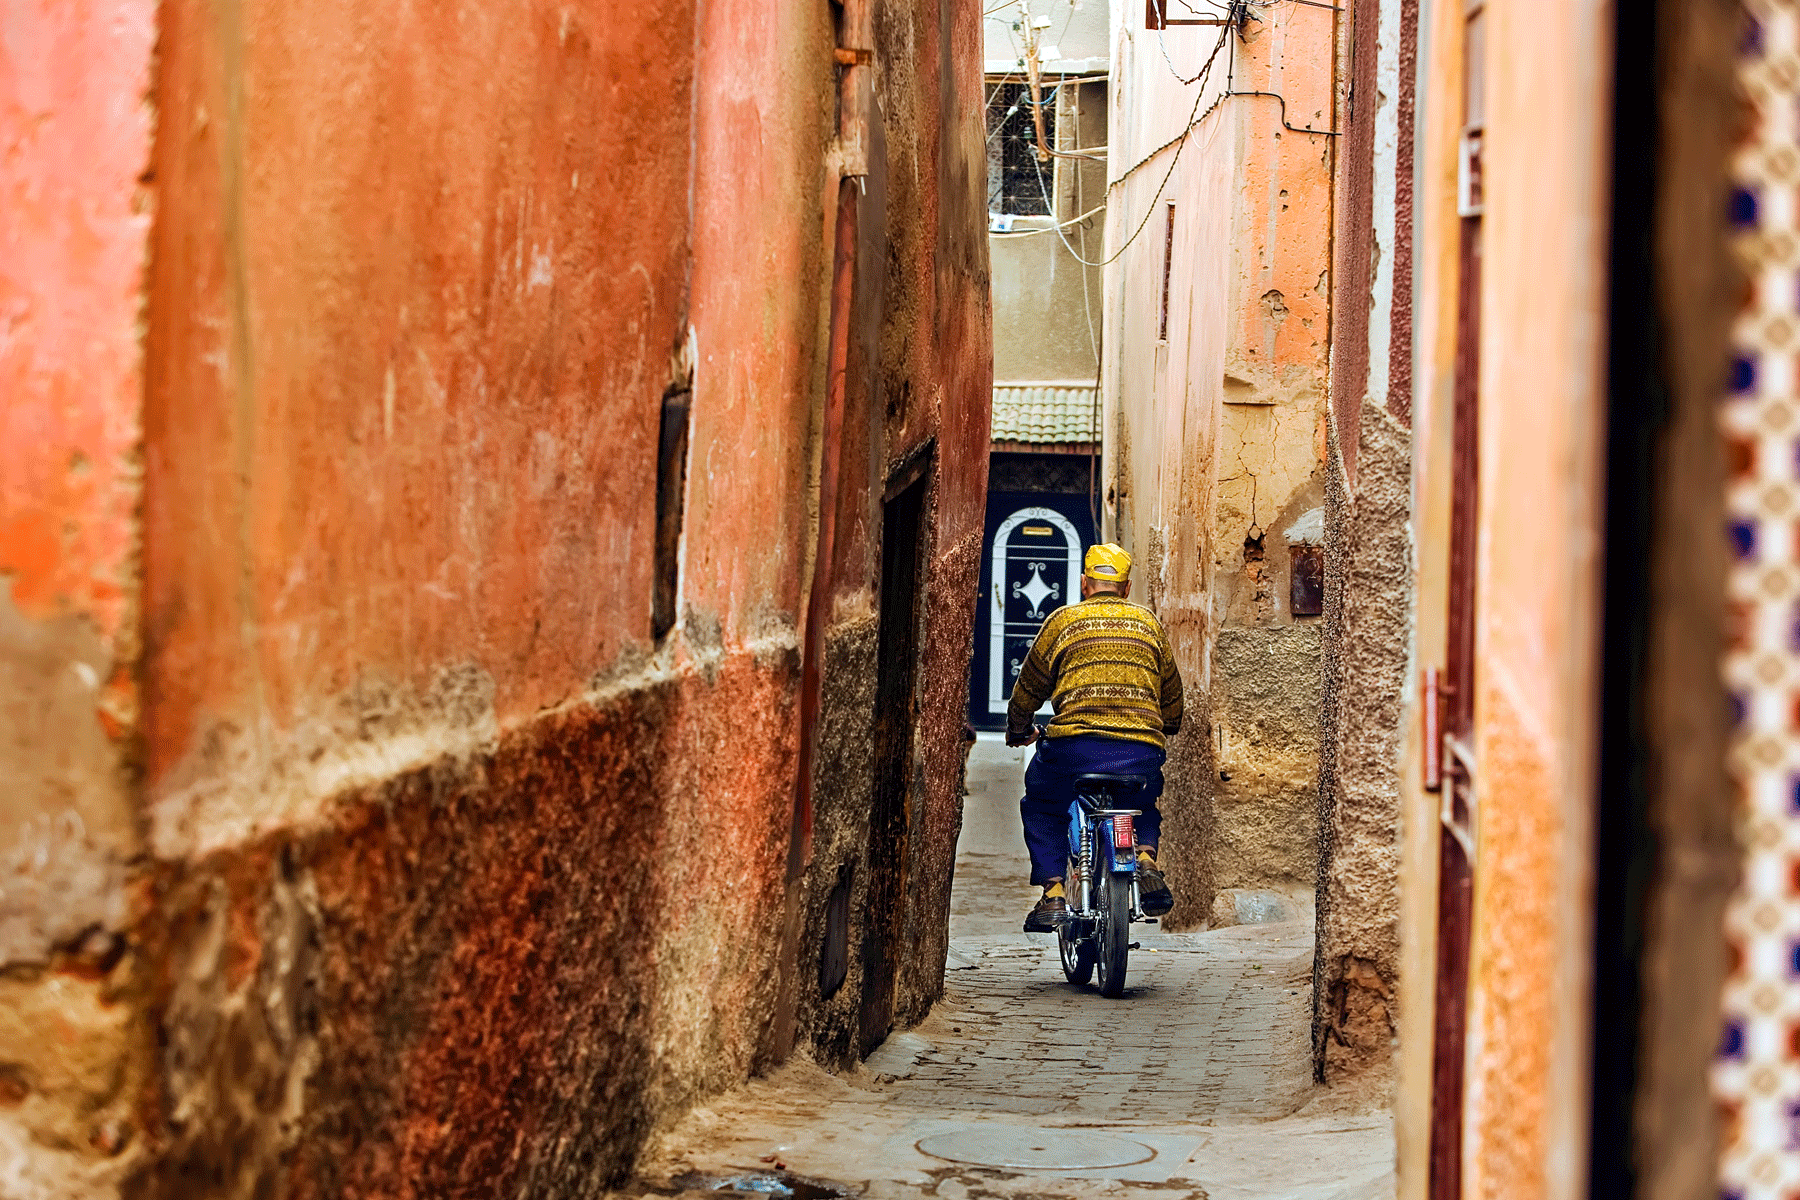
[1006,596,1181,747]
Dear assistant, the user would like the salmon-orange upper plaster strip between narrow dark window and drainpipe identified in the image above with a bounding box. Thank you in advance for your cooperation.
[682,2,837,644]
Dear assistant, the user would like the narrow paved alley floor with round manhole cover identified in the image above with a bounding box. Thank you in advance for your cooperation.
[641,734,1393,1200]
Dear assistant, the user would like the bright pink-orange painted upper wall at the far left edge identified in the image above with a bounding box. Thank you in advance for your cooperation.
[0,0,157,639]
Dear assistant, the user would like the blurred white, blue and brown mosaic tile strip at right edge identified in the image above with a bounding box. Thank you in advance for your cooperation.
[1714,0,1800,1200]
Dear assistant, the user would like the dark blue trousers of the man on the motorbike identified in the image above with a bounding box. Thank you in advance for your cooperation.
[1019,734,1168,885]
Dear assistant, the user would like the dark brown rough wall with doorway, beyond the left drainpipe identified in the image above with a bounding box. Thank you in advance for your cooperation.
[796,0,992,1063]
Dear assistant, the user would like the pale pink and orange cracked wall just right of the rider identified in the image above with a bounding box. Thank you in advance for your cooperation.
[1105,5,1336,923]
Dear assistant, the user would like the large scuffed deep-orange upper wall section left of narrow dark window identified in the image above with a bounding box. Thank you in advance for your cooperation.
[144,0,693,792]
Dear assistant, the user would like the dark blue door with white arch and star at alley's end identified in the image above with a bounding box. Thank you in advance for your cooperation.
[968,493,1089,729]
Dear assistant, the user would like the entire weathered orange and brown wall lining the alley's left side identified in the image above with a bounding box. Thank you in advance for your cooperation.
[0,0,990,1196]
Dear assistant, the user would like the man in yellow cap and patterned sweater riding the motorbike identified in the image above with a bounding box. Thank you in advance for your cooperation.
[1006,542,1181,934]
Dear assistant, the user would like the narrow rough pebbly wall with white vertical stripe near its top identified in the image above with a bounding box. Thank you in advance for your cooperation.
[1312,0,1411,1101]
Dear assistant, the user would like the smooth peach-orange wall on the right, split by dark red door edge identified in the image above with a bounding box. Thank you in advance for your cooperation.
[1397,2,1611,1200]
